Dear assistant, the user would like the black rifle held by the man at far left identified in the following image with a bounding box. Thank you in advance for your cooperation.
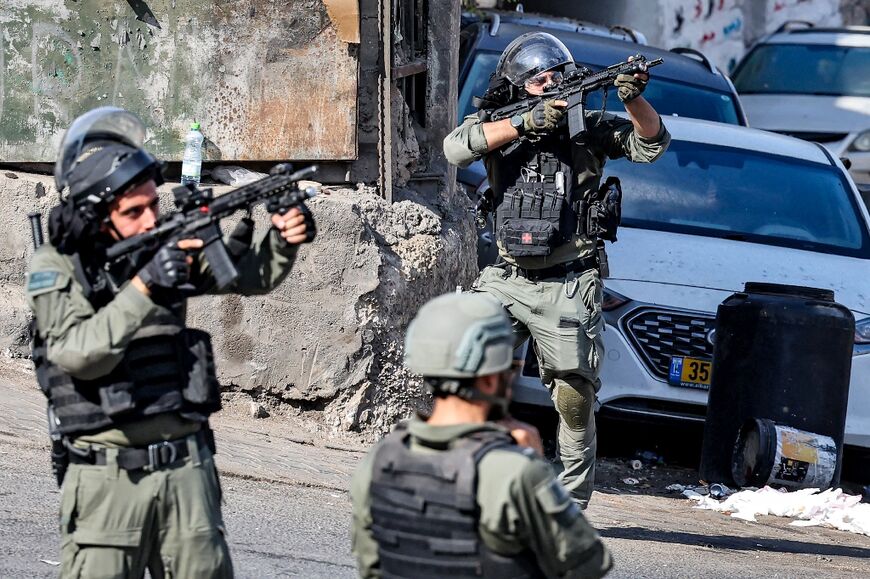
[106,163,317,289]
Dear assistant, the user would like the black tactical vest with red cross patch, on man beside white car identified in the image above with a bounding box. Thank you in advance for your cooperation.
[487,128,622,257]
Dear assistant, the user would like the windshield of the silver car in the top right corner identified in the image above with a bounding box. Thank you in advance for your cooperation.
[734,44,870,97]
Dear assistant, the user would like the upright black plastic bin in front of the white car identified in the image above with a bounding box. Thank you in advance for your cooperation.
[700,282,855,485]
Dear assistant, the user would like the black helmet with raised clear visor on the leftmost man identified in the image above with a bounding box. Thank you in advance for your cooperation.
[54,107,163,214]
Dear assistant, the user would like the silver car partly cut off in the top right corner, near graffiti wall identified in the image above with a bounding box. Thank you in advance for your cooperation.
[732,23,870,183]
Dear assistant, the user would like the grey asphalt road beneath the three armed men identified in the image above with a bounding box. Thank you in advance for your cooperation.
[0,362,870,579]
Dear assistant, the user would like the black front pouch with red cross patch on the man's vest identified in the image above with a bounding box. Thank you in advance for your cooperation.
[496,182,577,257]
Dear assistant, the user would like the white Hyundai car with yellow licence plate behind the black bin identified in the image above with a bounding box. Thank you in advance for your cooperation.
[514,117,870,448]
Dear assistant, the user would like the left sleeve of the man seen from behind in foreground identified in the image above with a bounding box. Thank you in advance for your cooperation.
[350,446,381,579]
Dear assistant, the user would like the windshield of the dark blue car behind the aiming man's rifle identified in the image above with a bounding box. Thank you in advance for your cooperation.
[459,51,740,125]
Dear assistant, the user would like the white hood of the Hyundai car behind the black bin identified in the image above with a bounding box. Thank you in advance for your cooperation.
[605,227,870,319]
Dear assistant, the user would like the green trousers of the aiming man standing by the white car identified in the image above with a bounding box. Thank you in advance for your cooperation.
[474,266,604,509]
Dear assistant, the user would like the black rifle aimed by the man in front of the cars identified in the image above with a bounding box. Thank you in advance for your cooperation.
[476,54,664,143]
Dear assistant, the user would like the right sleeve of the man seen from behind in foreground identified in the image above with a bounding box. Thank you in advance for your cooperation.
[478,451,613,579]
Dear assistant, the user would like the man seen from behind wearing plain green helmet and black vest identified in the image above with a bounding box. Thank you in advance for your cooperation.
[351,294,612,579]
